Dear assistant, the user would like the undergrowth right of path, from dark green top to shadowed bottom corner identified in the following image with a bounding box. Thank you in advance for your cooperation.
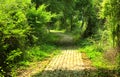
[79,38,119,77]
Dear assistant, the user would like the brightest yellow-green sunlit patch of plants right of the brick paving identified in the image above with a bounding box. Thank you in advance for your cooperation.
[80,45,105,67]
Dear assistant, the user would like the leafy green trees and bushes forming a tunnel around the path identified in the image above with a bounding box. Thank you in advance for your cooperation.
[0,0,120,77]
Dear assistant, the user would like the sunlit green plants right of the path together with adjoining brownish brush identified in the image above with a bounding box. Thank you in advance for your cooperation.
[79,39,116,69]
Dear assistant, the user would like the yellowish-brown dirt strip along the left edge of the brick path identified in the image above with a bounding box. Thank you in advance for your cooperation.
[17,57,53,77]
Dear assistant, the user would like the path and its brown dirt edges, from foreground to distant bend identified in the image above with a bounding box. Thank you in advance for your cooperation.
[18,32,95,77]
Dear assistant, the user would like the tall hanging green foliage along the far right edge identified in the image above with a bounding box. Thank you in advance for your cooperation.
[101,0,120,73]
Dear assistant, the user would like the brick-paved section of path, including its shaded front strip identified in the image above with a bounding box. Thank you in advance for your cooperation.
[39,49,84,77]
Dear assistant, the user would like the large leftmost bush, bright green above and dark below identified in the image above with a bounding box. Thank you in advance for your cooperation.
[0,0,30,76]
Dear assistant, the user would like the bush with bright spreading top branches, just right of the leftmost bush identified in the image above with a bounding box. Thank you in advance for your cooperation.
[27,5,55,44]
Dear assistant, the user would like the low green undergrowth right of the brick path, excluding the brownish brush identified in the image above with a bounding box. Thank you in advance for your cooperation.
[79,39,114,69]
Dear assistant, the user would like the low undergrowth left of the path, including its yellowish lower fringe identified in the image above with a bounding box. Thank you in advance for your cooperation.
[13,44,60,76]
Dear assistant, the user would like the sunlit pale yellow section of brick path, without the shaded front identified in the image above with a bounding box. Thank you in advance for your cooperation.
[45,50,83,70]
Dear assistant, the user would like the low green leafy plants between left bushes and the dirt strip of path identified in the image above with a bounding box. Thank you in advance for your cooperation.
[19,45,59,66]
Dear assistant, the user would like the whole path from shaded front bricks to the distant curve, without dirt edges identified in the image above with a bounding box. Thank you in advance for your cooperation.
[34,33,91,77]
